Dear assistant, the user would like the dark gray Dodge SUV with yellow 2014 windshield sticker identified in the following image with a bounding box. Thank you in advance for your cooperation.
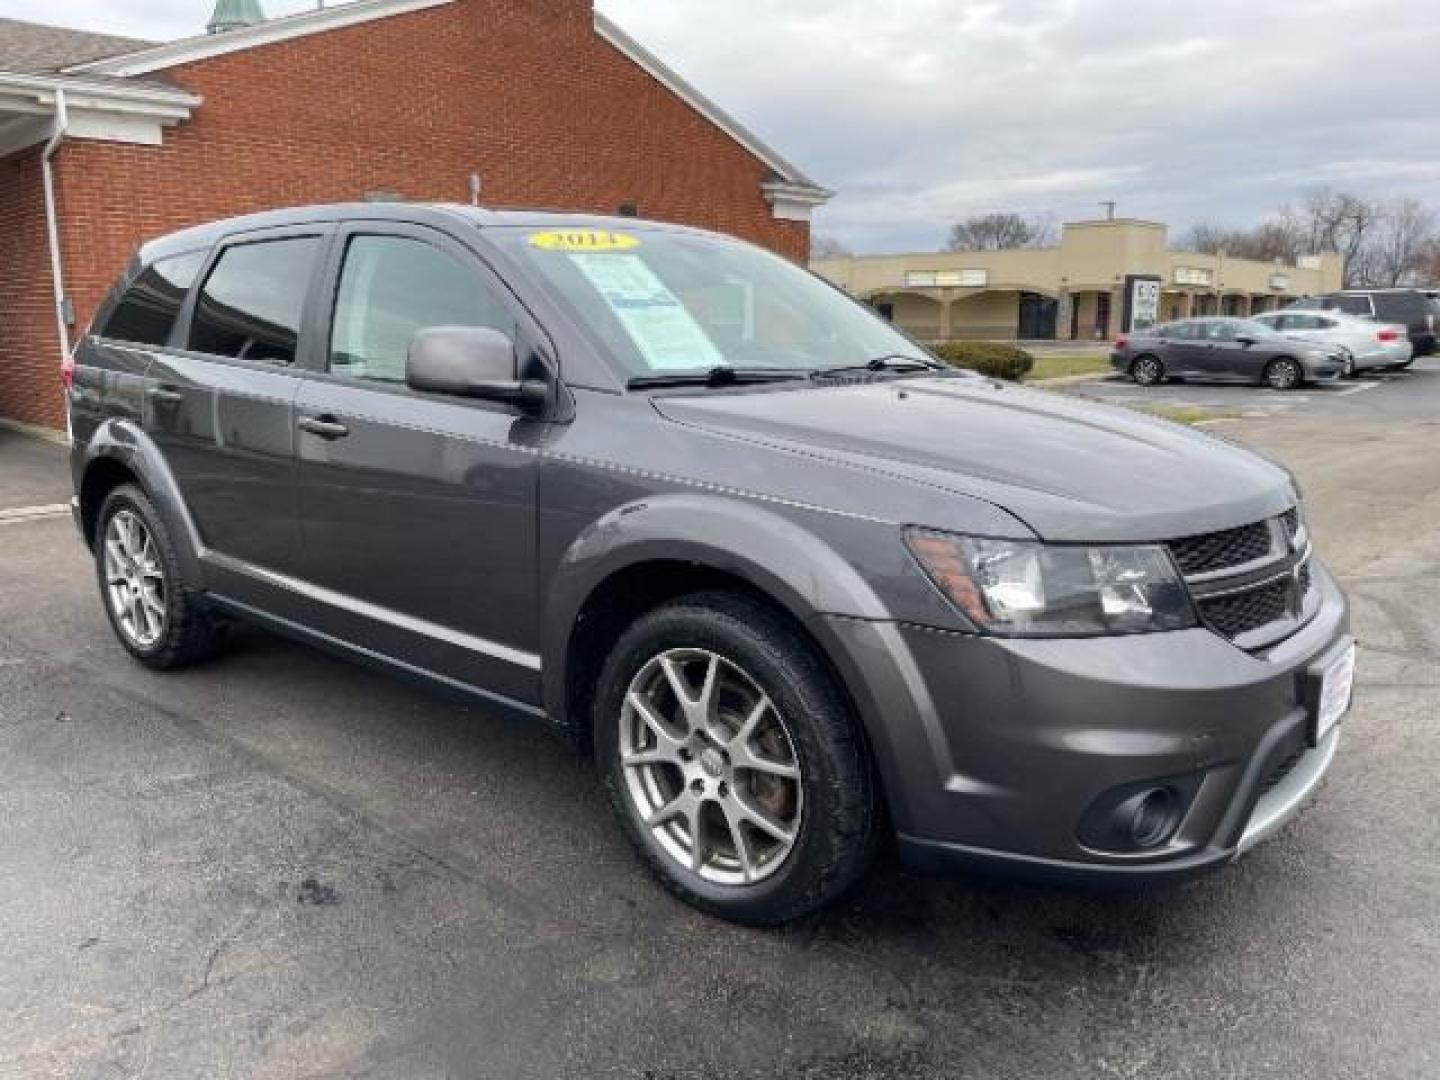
[69,204,1354,924]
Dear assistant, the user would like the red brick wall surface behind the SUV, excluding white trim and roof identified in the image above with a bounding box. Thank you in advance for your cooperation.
[0,0,809,426]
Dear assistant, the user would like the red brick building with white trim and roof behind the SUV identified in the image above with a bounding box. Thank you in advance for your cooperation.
[0,0,828,428]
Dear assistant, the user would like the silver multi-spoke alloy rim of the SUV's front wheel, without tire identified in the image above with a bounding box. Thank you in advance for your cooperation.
[619,649,804,886]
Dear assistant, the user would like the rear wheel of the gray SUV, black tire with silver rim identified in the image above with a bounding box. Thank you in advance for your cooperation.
[95,484,223,671]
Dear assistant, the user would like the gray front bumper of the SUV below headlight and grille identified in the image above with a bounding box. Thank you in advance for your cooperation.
[828,564,1349,883]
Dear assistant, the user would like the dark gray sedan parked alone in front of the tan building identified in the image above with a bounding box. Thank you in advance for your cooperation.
[1110,318,1345,390]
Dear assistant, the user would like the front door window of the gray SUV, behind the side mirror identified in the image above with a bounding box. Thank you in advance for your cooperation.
[330,236,516,383]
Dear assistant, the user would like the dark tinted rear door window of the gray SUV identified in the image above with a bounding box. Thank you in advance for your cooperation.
[190,236,320,364]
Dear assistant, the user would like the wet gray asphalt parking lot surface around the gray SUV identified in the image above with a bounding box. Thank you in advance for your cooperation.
[0,361,1440,1080]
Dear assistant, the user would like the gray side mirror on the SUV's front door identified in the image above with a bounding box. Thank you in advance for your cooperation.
[405,327,550,409]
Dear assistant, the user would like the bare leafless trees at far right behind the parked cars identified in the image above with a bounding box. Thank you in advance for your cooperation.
[1181,187,1440,288]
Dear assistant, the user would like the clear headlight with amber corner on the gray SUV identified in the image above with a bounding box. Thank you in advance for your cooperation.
[906,528,1198,638]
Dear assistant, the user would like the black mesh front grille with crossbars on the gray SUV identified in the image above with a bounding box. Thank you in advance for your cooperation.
[1168,508,1310,648]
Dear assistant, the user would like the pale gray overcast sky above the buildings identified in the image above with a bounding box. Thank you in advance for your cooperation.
[11,0,1440,251]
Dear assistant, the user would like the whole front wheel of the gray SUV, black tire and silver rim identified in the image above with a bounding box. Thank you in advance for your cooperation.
[593,592,880,926]
